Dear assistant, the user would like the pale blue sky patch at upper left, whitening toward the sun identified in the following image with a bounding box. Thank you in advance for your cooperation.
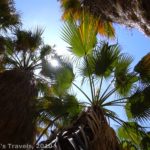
[15,0,68,54]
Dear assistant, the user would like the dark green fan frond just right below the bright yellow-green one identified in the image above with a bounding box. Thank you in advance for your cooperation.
[80,42,120,77]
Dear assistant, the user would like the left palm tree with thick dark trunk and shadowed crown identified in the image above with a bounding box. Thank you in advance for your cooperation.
[0,29,51,144]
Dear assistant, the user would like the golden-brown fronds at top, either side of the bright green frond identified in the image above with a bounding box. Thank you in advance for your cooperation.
[60,0,115,38]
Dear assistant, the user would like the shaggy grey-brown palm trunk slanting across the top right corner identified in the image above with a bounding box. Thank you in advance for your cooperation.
[80,0,150,36]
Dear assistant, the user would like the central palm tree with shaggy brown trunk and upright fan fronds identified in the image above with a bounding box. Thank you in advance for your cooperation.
[38,15,147,150]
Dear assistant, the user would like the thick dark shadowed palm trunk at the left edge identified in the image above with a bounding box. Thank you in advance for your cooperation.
[0,69,37,144]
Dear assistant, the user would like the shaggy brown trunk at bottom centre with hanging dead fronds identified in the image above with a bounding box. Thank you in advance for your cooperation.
[43,106,119,150]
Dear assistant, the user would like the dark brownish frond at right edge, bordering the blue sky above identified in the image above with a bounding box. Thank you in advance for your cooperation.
[134,53,150,83]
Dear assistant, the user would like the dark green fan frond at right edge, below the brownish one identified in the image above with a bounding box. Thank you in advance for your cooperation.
[125,86,150,121]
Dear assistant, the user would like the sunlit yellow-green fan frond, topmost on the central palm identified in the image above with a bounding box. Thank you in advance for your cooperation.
[62,15,97,57]
